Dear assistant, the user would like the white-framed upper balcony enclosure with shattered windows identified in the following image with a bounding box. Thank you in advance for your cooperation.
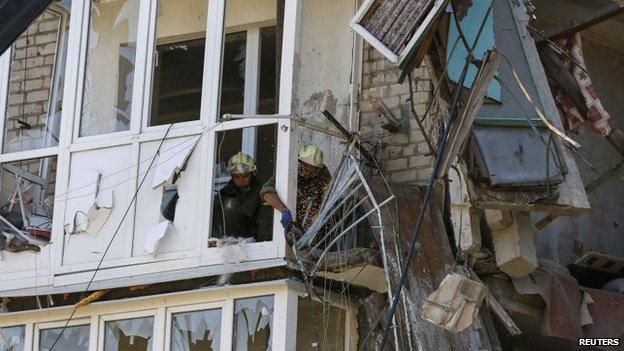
[0,0,299,292]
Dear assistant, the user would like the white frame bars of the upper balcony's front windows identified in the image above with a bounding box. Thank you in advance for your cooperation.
[40,0,302,285]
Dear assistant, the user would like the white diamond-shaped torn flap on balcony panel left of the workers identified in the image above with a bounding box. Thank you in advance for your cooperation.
[152,136,199,189]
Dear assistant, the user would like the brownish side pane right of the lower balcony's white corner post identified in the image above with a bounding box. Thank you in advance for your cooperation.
[296,298,346,351]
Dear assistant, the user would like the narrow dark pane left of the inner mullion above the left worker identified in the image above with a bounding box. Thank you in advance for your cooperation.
[219,32,247,117]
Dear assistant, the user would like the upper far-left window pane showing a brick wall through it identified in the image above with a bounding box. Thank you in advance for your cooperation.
[2,0,71,153]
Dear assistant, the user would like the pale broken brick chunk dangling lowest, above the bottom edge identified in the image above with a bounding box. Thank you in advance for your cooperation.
[421,273,486,333]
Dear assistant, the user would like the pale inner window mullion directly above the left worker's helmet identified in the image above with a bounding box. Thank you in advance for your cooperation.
[241,27,260,158]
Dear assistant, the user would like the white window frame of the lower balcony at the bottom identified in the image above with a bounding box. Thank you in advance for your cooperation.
[0,280,357,351]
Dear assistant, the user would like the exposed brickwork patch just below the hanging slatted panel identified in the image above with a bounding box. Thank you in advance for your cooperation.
[359,44,441,183]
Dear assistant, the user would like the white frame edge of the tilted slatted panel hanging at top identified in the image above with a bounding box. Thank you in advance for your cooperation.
[349,0,449,66]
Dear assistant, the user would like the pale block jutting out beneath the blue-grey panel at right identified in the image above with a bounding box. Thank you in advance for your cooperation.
[485,210,537,278]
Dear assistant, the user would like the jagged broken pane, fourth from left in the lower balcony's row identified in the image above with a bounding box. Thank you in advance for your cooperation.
[171,309,221,351]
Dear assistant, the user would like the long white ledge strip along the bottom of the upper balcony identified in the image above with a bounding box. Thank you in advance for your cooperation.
[0,259,288,297]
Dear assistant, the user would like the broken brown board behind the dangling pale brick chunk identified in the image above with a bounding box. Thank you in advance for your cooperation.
[369,180,498,350]
